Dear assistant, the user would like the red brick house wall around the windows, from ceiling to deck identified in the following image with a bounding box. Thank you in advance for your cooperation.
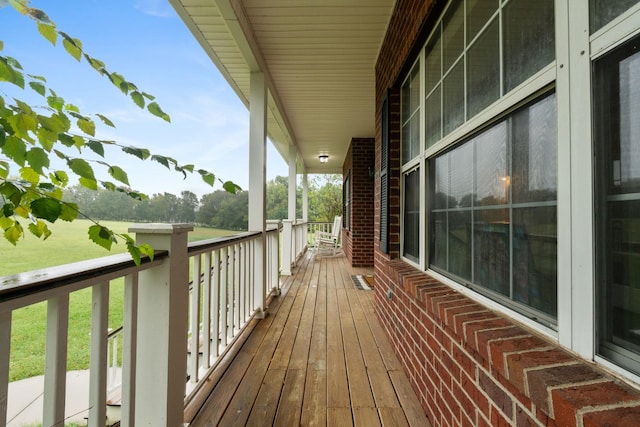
[374,0,640,427]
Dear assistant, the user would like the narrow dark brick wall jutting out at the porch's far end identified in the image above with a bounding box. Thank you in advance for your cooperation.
[342,138,375,267]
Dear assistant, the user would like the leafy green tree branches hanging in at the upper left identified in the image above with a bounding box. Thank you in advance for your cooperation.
[0,0,239,263]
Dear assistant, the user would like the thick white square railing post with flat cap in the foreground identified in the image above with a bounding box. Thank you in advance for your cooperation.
[129,224,191,426]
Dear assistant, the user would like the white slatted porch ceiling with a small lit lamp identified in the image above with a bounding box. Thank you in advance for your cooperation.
[169,0,395,173]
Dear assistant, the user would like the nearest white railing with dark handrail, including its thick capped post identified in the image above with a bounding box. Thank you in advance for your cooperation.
[0,224,280,427]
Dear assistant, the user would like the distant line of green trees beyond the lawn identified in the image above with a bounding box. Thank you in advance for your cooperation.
[64,175,342,231]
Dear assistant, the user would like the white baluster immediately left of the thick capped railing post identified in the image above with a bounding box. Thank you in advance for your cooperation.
[120,273,138,426]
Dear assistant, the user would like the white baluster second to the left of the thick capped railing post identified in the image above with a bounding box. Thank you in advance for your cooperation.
[89,282,109,427]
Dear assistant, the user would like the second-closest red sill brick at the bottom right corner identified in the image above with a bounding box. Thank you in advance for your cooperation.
[551,381,640,426]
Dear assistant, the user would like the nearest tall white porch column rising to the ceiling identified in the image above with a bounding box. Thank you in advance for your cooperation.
[249,72,267,317]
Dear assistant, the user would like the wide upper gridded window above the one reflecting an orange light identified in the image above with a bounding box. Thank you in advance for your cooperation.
[422,0,555,147]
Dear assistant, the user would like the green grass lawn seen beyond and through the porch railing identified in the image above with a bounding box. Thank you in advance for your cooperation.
[0,220,235,381]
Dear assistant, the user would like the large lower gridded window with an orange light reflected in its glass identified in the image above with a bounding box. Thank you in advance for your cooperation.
[429,94,557,318]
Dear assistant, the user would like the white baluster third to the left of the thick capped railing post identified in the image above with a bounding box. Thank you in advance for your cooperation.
[42,294,69,425]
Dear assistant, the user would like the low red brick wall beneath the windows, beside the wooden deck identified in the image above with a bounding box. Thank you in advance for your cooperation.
[375,260,640,427]
